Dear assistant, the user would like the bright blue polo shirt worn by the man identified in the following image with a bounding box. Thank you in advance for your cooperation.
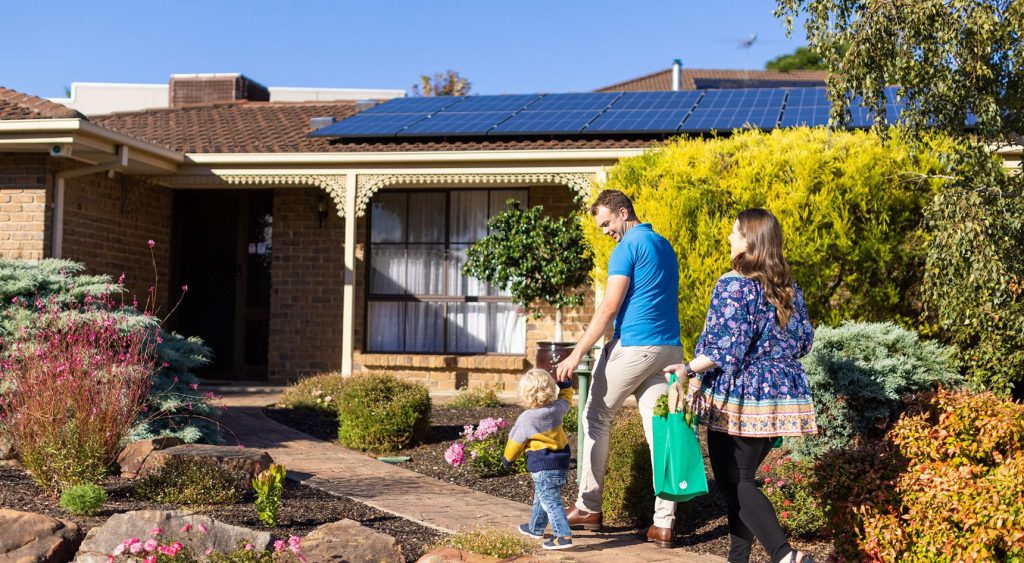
[608,223,682,346]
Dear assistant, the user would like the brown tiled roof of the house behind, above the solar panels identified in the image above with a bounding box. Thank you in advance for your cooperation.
[596,69,828,92]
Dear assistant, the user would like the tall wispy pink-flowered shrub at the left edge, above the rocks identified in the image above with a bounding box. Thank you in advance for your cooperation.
[0,296,157,493]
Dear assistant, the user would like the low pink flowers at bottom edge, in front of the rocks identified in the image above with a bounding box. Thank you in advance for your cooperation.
[106,524,306,563]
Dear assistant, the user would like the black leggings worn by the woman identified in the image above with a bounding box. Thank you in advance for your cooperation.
[708,430,791,563]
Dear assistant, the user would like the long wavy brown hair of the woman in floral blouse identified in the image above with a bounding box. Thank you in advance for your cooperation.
[732,208,793,329]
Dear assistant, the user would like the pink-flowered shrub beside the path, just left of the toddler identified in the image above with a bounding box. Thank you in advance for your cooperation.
[444,418,526,477]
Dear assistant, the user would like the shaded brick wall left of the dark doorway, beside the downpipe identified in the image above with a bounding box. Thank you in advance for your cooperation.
[63,164,177,314]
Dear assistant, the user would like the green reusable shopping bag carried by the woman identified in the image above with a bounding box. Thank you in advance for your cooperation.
[652,374,708,502]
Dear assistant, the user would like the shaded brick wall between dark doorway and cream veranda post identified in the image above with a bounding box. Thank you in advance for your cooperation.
[267,188,345,383]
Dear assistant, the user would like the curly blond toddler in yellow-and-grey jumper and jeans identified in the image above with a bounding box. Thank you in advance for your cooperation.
[503,370,572,550]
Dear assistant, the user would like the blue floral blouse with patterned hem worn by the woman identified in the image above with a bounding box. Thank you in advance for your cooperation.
[690,272,817,437]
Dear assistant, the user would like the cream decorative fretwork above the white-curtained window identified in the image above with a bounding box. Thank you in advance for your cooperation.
[355,172,597,217]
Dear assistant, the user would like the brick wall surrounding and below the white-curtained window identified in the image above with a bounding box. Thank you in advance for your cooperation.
[354,186,594,391]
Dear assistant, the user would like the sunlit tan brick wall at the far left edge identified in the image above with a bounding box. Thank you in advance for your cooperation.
[0,153,56,260]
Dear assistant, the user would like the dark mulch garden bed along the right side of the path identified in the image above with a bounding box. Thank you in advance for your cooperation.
[264,405,833,561]
